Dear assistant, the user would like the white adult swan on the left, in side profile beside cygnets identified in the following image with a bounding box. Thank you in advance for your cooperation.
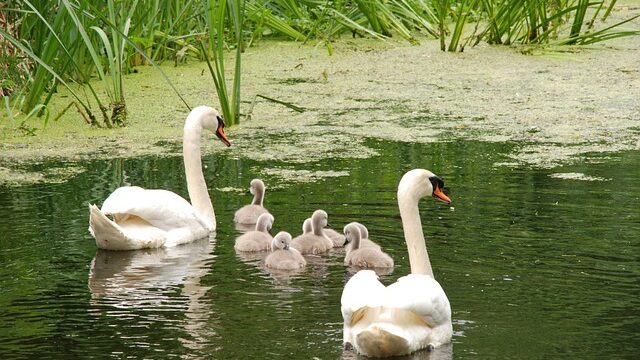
[89,106,231,250]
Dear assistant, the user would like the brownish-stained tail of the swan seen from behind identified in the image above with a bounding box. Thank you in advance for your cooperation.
[356,326,411,357]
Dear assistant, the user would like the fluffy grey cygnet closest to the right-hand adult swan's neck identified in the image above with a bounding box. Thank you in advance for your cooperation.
[344,223,393,268]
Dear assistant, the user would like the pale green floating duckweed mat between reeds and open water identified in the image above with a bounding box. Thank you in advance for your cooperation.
[0,7,640,184]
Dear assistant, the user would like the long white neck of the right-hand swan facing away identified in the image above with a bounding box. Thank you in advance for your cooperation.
[398,192,435,279]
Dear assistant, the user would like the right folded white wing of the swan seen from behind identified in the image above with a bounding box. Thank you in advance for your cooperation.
[384,274,451,327]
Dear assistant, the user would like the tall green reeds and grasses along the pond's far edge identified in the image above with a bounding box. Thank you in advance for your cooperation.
[0,0,640,133]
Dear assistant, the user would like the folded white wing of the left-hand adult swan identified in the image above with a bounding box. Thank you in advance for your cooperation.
[101,186,207,230]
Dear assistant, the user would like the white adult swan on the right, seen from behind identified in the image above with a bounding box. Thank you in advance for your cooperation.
[342,169,453,357]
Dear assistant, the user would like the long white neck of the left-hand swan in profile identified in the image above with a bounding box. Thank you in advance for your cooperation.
[182,112,216,228]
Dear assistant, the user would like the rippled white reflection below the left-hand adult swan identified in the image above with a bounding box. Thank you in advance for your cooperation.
[89,234,216,349]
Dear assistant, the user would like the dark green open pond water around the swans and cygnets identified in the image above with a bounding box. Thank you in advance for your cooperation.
[0,140,640,359]
